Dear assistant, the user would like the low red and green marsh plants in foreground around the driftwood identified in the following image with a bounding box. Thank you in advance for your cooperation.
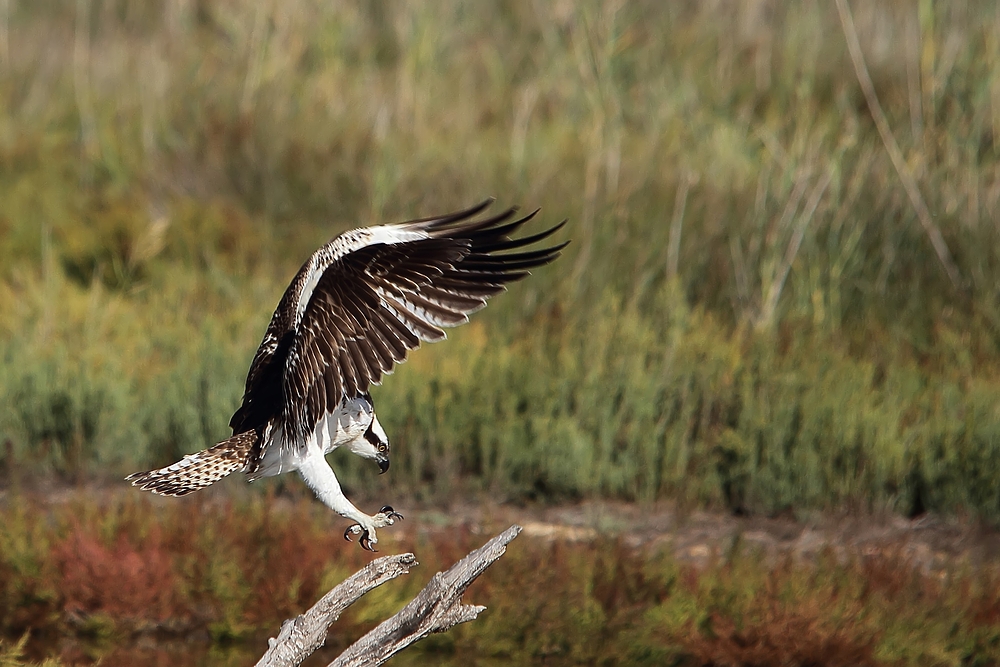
[0,494,1000,666]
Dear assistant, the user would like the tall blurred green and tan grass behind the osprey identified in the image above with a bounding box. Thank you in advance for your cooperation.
[0,0,1000,523]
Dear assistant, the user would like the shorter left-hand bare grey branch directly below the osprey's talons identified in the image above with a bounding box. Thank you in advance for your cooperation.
[257,553,417,667]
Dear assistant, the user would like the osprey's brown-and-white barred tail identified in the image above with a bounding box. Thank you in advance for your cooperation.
[125,430,260,496]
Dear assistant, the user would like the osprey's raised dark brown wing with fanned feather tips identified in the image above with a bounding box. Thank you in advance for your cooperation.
[278,200,566,442]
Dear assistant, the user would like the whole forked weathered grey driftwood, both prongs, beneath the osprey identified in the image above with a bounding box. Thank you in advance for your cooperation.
[257,526,521,667]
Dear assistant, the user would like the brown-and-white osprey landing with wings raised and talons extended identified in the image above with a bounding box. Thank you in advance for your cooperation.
[126,199,568,551]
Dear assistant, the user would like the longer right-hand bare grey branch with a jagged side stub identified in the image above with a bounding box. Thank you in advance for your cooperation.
[330,526,521,667]
